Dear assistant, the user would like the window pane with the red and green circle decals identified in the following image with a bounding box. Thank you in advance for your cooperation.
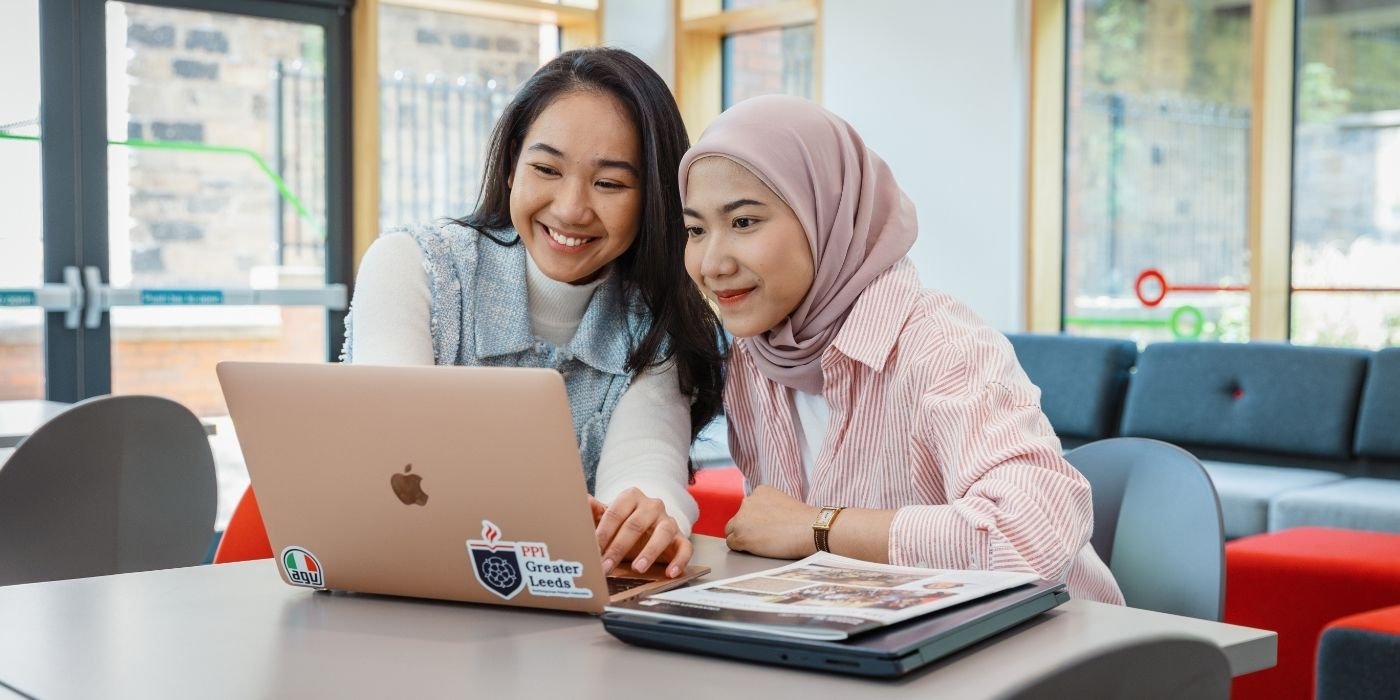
[1063,0,1250,340]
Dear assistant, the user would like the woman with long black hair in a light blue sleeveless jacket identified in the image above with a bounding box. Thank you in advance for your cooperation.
[344,48,724,575]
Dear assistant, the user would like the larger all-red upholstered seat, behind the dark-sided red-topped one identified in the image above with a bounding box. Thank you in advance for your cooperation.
[1225,528,1400,700]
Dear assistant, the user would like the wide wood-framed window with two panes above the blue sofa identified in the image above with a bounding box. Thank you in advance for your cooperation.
[1028,0,1400,349]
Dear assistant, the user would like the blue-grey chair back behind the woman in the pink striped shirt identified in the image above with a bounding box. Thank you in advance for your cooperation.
[1064,437,1225,620]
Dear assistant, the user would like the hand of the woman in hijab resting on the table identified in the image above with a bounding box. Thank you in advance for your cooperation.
[724,486,822,559]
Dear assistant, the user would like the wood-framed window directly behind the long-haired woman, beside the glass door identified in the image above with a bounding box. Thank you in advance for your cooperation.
[354,0,599,266]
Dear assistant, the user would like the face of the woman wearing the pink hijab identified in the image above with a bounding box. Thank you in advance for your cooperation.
[683,155,815,337]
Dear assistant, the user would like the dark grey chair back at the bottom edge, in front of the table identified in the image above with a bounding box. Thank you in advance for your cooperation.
[1000,636,1231,700]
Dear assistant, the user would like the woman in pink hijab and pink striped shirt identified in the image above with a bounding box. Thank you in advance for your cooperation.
[679,95,1123,603]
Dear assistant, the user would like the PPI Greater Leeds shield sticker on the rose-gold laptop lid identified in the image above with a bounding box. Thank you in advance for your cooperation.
[466,519,594,601]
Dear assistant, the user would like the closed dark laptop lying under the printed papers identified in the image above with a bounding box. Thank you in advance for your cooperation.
[603,581,1070,678]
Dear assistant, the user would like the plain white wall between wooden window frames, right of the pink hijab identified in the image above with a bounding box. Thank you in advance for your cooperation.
[817,0,1029,330]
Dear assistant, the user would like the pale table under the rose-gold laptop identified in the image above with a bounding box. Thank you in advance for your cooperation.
[0,536,1278,700]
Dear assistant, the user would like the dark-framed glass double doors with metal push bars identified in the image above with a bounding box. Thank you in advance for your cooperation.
[20,0,351,525]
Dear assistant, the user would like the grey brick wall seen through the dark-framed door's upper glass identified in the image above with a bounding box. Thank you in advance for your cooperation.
[111,4,325,286]
